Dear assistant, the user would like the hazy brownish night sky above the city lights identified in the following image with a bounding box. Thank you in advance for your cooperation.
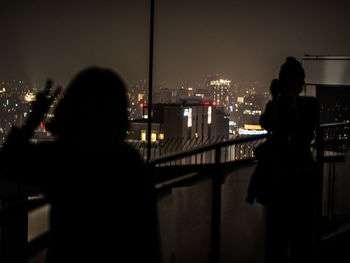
[0,0,350,91]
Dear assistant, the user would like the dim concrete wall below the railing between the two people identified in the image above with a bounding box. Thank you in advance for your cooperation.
[158,165,265,263]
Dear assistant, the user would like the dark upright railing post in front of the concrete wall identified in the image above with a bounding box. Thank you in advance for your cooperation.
[211,147,222,263]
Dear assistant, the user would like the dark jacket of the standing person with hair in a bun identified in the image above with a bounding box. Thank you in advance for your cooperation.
[247,97,319,205]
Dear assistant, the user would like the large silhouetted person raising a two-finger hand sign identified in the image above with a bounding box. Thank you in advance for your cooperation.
[1,67,159,262]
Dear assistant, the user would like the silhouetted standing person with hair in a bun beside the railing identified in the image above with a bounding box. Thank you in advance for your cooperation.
[247,57,319,262]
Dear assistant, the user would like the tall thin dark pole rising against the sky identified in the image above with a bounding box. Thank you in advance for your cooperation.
[147,0,154,162]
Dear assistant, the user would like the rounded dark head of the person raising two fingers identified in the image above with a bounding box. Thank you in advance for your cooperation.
[48,67,128,147]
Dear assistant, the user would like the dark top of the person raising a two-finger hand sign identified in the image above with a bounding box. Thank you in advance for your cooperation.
[0,129,158,262]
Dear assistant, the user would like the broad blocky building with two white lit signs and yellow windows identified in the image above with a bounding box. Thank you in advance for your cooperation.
[128,102,229,143]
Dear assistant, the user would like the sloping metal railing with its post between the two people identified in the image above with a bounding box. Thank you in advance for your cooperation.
[151,135,267,263]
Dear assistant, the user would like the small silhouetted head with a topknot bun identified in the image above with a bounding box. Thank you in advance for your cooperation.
[279,57,305,94]
